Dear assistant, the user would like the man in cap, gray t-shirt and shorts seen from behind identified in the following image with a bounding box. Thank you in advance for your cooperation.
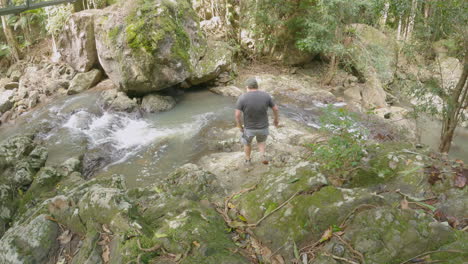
[235,78,279,165]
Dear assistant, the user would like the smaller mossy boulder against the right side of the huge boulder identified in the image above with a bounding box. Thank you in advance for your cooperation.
[189,41,234,85]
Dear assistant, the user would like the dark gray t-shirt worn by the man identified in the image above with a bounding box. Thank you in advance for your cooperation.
[236,91,275,129]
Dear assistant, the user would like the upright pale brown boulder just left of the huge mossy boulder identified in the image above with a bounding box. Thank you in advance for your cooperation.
[57,10,100,72]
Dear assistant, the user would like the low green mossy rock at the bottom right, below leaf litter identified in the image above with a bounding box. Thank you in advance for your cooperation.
[344,208,456,263]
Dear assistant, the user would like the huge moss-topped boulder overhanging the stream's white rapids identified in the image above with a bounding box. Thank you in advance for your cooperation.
[95,0,206,95]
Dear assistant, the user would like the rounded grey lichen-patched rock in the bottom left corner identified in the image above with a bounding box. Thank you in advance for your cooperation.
[0,215,59,264]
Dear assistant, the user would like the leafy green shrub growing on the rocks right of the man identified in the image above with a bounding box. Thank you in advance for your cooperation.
[310,105,368,174]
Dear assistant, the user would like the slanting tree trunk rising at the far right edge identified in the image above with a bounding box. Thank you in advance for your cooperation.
[439,48,468,153]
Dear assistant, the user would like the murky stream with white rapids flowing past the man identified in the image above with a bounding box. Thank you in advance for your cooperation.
[0,91,468,187]
